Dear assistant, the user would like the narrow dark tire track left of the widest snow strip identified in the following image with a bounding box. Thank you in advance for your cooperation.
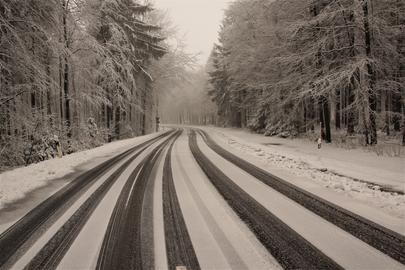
[163,130,200,270]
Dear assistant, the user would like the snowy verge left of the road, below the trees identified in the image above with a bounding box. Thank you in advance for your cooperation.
[0,133,160,209]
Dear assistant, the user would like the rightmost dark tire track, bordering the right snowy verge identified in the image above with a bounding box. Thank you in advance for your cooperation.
[199,130,405,264]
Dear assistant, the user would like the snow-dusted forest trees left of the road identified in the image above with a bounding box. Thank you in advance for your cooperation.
[0,0,166,167]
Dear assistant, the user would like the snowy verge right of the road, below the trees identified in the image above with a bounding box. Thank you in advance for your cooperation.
[203,127,405,219]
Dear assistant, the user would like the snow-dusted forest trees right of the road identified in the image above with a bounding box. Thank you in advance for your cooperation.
[209,0,405,145]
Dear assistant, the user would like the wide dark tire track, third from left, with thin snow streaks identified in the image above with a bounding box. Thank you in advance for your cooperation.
[96,132,179,270]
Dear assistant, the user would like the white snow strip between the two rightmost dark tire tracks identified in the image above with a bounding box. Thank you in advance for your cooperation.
[197,136,403,270]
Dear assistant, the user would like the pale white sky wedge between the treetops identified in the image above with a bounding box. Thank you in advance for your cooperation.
[153,0,230,64]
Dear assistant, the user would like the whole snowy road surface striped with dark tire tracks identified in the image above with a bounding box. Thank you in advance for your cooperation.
[0,129,405,270]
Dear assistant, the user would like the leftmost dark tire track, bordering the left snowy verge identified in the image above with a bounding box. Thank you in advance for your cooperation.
[0,132,171,268]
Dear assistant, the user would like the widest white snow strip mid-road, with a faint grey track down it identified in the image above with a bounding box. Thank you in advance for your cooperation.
[172,133,281,269]
